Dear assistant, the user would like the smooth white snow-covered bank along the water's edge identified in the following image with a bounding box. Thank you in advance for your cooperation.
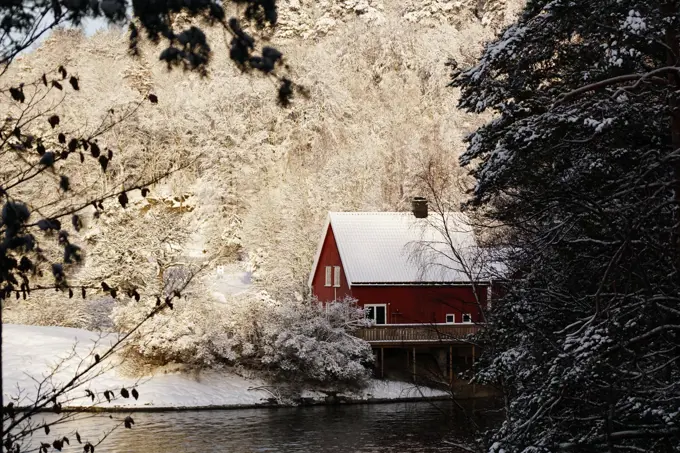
[2,324,445,408]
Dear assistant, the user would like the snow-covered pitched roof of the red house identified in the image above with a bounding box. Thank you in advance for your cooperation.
[309,212,500,286]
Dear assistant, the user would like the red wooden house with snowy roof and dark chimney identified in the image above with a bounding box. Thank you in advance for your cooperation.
[309,199,500,324]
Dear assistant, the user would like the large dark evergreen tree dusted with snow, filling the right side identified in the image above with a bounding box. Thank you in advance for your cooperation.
[453,0,680,452]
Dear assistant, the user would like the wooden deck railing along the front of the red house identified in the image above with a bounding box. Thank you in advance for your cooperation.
[356,324,481,343]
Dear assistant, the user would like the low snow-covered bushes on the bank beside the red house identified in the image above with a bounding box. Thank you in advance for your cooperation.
[113,292,373,385]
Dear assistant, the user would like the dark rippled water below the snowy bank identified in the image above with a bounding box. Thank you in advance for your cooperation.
[26,403,488,453]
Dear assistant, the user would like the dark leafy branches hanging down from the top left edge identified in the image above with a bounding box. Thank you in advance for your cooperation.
[0,0,299,103]
